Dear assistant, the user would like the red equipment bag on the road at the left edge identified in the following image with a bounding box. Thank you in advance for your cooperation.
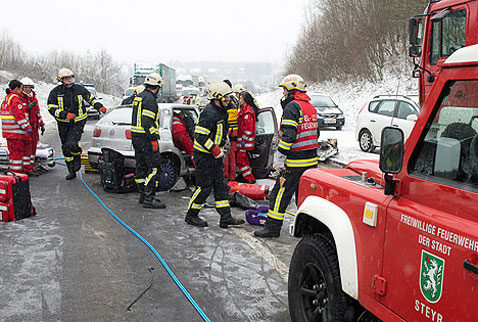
[0,172,36,221]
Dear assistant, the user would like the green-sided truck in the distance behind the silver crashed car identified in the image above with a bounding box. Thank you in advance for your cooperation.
[130,63,177,103]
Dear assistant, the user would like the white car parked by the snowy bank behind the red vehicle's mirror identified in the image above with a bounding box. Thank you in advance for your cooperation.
[355,95,420,152]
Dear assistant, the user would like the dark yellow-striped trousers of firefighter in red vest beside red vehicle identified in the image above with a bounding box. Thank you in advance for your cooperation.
[266,166,315,230]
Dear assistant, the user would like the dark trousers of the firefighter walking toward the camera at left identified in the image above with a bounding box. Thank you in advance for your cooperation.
[58,120,86,172]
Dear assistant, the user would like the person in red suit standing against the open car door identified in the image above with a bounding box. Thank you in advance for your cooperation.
[237,92,259,183]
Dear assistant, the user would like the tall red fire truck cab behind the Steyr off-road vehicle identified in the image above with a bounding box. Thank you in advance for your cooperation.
[409,0,478,105]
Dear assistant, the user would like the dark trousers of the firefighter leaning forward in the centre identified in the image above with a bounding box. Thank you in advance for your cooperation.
[187,151,231,217]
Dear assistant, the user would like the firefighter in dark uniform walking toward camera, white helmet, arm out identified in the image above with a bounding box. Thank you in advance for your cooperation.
[47,68,106,180]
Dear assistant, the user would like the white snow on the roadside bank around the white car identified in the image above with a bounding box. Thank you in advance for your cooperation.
[256,75,418,164]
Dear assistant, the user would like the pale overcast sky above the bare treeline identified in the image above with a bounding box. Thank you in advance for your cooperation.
[0,0,309,63]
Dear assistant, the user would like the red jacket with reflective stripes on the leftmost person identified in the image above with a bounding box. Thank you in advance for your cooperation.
[0,91,32,140]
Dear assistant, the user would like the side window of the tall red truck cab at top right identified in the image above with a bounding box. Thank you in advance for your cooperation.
[441,10,466,58]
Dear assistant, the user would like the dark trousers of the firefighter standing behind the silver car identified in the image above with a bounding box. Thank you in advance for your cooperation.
[132,136,160,189]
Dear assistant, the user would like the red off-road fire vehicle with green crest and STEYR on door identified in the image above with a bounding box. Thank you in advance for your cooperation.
[288,44,478,322]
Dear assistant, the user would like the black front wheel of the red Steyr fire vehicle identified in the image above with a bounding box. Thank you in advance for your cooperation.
[288,234,347,322]
